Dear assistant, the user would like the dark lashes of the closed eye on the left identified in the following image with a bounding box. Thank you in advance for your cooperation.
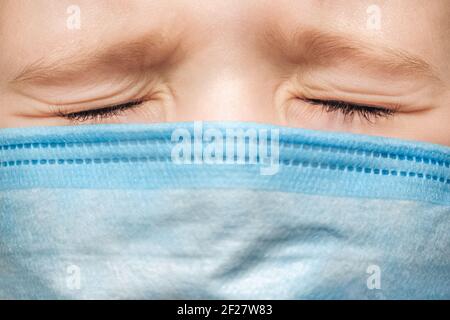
[58,100,144,122]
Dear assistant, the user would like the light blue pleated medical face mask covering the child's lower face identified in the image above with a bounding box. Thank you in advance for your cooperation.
[0,123,450,299]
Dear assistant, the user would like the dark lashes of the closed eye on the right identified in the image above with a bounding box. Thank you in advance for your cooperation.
[302,99,396,123]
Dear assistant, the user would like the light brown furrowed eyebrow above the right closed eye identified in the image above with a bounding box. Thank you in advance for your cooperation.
[264,27,441,82]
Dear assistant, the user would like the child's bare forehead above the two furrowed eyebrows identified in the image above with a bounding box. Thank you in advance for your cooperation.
[0,0,450,70]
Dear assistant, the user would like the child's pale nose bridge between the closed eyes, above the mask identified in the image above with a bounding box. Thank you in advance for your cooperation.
[171,39,273,122]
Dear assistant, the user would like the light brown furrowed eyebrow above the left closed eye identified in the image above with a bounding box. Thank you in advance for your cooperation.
[11,35,175,85]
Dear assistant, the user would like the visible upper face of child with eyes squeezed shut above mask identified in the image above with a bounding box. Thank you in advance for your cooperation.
[0,0,450,145]
